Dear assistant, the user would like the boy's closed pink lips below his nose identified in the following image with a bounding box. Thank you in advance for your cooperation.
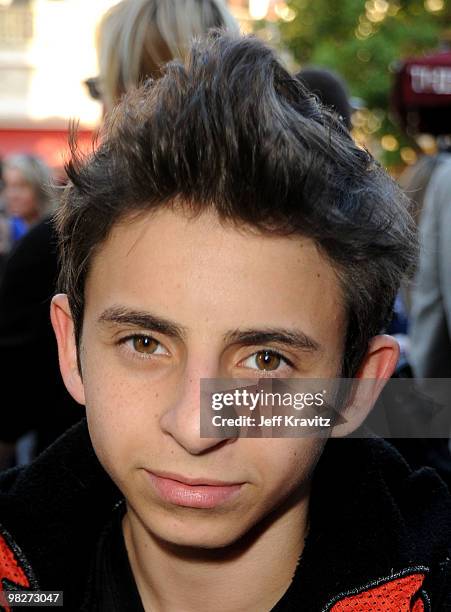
[147,472,243,508]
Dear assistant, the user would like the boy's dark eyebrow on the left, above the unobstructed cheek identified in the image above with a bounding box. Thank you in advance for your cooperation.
[97,306,186,339]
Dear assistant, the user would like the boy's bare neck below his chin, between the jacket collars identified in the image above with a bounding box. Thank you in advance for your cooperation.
[123,491,309,612]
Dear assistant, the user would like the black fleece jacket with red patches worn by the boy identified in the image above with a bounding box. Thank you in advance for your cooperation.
[0,420,451,612]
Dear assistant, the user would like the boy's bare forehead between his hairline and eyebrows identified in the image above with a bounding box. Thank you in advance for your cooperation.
[86,209,344,344]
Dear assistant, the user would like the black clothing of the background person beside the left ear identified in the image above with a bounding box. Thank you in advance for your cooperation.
[0,218,83,452]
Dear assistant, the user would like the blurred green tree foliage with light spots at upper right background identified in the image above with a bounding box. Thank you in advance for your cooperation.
[279,0,451,164]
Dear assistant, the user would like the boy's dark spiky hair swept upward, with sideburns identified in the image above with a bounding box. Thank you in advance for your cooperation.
[57,32,416,376]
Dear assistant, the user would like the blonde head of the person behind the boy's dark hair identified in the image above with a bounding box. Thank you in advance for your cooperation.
[87,0,239,111]
